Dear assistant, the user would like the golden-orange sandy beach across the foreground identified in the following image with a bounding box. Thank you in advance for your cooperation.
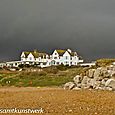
[0,87,115,115]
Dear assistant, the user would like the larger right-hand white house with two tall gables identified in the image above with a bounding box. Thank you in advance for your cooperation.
[51,49,83,66]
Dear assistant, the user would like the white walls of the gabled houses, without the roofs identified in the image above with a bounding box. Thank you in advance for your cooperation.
[21,50,83,66]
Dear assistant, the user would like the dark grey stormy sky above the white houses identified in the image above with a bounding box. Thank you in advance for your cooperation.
[0,0,115,60]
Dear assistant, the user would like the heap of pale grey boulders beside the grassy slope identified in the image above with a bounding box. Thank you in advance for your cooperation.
[64,65,115,91]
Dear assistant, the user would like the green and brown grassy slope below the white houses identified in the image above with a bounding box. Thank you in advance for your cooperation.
[0,67,87,87]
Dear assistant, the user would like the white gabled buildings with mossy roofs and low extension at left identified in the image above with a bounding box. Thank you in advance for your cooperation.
[0,49,83,67]
